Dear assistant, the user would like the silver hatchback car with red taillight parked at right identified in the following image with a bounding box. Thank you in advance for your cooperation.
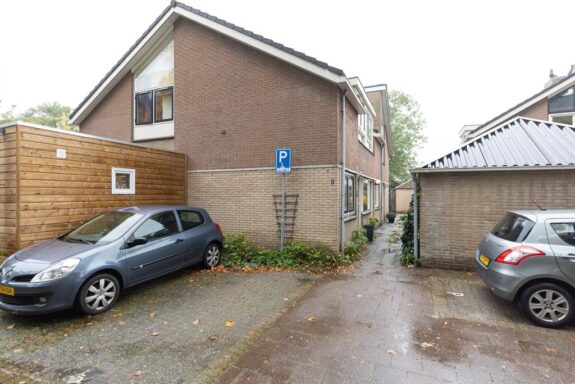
[475,210,575,328]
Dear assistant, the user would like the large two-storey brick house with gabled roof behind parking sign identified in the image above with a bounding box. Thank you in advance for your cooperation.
[67,2,390,249]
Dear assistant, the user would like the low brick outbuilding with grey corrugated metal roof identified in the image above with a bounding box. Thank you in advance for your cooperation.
[412,117,575,269]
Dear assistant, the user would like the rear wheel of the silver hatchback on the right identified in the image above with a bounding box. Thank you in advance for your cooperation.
[519,283,575,328]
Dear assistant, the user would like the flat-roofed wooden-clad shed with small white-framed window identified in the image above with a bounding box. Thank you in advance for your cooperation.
[0,122,187,258]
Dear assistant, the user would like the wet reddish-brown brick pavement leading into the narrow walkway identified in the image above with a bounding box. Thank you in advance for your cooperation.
[219,225,575,384]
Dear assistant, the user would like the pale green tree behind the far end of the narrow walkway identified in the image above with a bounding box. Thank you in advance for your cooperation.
[389,90,427,187]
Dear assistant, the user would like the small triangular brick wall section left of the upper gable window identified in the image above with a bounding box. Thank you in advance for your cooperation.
[80,73,134,141]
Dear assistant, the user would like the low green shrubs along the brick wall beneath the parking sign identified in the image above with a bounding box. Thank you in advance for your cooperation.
[222,233,353,271]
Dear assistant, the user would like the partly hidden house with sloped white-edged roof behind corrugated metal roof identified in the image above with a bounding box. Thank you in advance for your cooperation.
[460,65,575,142]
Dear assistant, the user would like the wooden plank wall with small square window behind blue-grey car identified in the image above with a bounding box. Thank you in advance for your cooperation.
[18,126,187,248]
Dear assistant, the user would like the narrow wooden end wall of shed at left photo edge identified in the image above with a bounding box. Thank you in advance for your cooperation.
[0,127,17,261]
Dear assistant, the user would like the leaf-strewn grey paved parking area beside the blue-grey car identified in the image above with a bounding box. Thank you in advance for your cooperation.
[0,270,313,384]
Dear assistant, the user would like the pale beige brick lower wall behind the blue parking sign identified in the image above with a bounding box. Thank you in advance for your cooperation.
[188,167,340,250]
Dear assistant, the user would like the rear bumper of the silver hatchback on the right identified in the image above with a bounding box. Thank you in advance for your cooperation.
[475,252,524,301]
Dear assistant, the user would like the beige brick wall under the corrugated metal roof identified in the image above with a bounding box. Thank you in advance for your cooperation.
[420,170,575,269]
